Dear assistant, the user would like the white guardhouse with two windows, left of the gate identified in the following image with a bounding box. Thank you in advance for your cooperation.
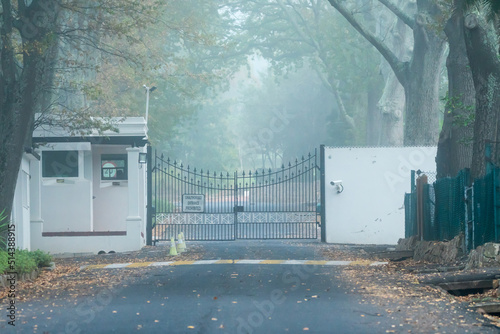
[12,117,147,254]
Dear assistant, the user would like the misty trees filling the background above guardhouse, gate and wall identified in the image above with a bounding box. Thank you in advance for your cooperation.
[0,0,500,235]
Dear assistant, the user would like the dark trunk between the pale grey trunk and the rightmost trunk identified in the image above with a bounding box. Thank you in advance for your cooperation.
[436,2,476,178]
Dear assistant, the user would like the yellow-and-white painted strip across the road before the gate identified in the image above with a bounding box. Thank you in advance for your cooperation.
[80,260,388,270]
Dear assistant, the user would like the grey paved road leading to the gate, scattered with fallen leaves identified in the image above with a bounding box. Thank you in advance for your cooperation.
[0,242,496,334]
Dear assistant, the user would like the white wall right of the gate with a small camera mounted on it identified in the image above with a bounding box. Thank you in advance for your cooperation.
[325,147,436,244]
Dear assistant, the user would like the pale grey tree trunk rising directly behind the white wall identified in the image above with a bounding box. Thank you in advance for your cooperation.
[402,0,446,146]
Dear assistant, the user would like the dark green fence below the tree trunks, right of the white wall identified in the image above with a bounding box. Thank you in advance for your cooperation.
[405,168,500,250]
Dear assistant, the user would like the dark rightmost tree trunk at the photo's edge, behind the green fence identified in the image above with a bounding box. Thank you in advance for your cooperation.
[464,14,500,179]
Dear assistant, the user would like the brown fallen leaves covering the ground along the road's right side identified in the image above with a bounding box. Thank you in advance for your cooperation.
[322,245,500,333]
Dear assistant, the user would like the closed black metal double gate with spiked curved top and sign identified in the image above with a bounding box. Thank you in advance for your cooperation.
[151,152,320,242]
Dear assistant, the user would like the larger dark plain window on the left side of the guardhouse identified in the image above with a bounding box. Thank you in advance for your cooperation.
[42,151,78,177]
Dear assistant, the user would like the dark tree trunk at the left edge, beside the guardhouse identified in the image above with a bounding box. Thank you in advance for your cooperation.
[0,1,57,240]
